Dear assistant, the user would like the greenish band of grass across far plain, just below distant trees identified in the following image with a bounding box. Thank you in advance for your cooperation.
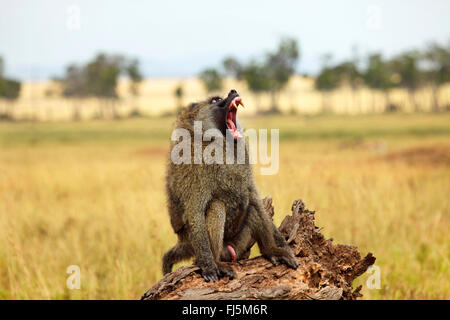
[0,114,450,147]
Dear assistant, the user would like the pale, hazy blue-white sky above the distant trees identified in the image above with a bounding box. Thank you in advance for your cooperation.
[0,0,450,80]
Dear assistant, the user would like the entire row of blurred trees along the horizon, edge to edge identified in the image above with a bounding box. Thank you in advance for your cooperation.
[0,38,450,120]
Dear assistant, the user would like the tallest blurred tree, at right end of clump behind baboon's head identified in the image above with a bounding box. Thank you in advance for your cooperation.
[265,38,300,112]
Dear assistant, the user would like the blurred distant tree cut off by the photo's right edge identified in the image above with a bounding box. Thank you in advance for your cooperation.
[424,42,450,112]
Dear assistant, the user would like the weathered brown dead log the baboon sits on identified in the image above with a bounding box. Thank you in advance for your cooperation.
[141,197,375,300]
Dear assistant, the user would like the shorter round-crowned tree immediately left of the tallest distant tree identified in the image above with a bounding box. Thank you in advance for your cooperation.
[241,61,271,112]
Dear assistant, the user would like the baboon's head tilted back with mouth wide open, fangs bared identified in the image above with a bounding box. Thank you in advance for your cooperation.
[177,90,244,139]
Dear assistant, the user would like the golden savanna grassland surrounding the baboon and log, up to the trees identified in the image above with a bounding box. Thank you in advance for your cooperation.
[0,113,450,299]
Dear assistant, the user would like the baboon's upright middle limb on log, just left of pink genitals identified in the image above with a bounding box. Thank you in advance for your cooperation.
[205,200,234,278]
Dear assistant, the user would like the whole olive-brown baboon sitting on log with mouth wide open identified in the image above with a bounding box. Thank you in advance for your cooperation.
[163,90,298,282]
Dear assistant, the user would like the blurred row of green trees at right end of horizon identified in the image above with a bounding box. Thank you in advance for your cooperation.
[315,42,450,112]
